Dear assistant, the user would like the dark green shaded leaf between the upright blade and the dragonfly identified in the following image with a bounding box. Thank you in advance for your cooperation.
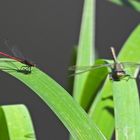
[81,60,108,111]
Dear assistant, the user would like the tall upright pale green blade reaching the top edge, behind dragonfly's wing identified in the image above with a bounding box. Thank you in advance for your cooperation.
[73,0,95,107]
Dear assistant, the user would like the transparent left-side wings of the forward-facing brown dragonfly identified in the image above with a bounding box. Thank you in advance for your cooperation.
[69,64,113,76]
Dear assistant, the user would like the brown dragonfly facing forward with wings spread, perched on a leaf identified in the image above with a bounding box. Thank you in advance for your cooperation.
[69,47,140,81]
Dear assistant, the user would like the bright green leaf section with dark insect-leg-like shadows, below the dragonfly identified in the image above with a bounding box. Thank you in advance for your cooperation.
[89,78,115,140]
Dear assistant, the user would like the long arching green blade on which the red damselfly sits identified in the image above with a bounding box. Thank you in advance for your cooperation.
[0,58,105,140]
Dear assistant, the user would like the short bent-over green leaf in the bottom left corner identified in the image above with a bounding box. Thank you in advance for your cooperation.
[0,105,36,140]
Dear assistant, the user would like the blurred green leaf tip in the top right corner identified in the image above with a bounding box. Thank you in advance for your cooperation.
[108,0,140,12]
